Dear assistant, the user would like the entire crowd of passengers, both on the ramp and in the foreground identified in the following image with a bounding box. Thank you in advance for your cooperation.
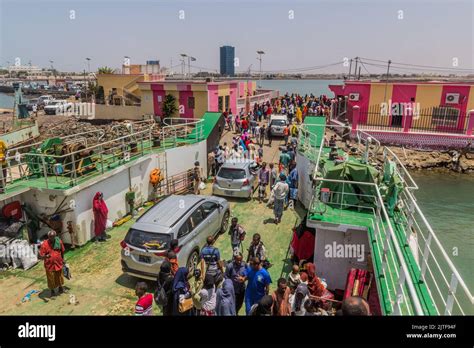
[129,95,369,316]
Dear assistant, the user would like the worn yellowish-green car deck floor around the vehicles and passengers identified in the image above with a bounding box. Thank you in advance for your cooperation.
[0,125,304,315]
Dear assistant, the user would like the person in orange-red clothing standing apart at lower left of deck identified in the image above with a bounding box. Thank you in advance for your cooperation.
[39,230,66,297]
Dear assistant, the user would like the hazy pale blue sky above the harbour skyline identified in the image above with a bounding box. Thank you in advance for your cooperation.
[0,0,474,73]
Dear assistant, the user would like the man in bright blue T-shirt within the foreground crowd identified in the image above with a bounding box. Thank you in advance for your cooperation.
[243,257,272,315]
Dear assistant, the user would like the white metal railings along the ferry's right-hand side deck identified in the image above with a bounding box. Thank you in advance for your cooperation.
[299,125,474,315]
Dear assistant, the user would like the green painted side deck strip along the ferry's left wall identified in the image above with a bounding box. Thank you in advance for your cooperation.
[0,112,221,200]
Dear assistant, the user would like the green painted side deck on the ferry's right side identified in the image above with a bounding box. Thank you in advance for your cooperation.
[305,117,437,315]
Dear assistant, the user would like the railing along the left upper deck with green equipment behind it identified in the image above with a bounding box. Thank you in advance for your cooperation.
[0,119,204,193]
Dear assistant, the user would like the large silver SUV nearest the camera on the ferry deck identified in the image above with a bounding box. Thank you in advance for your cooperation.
[120,195,230,280]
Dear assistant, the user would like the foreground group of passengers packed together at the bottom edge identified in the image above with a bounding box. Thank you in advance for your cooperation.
[135,232,370,316]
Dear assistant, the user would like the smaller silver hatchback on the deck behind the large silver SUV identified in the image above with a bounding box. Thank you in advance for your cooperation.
[212,159,258,199]
